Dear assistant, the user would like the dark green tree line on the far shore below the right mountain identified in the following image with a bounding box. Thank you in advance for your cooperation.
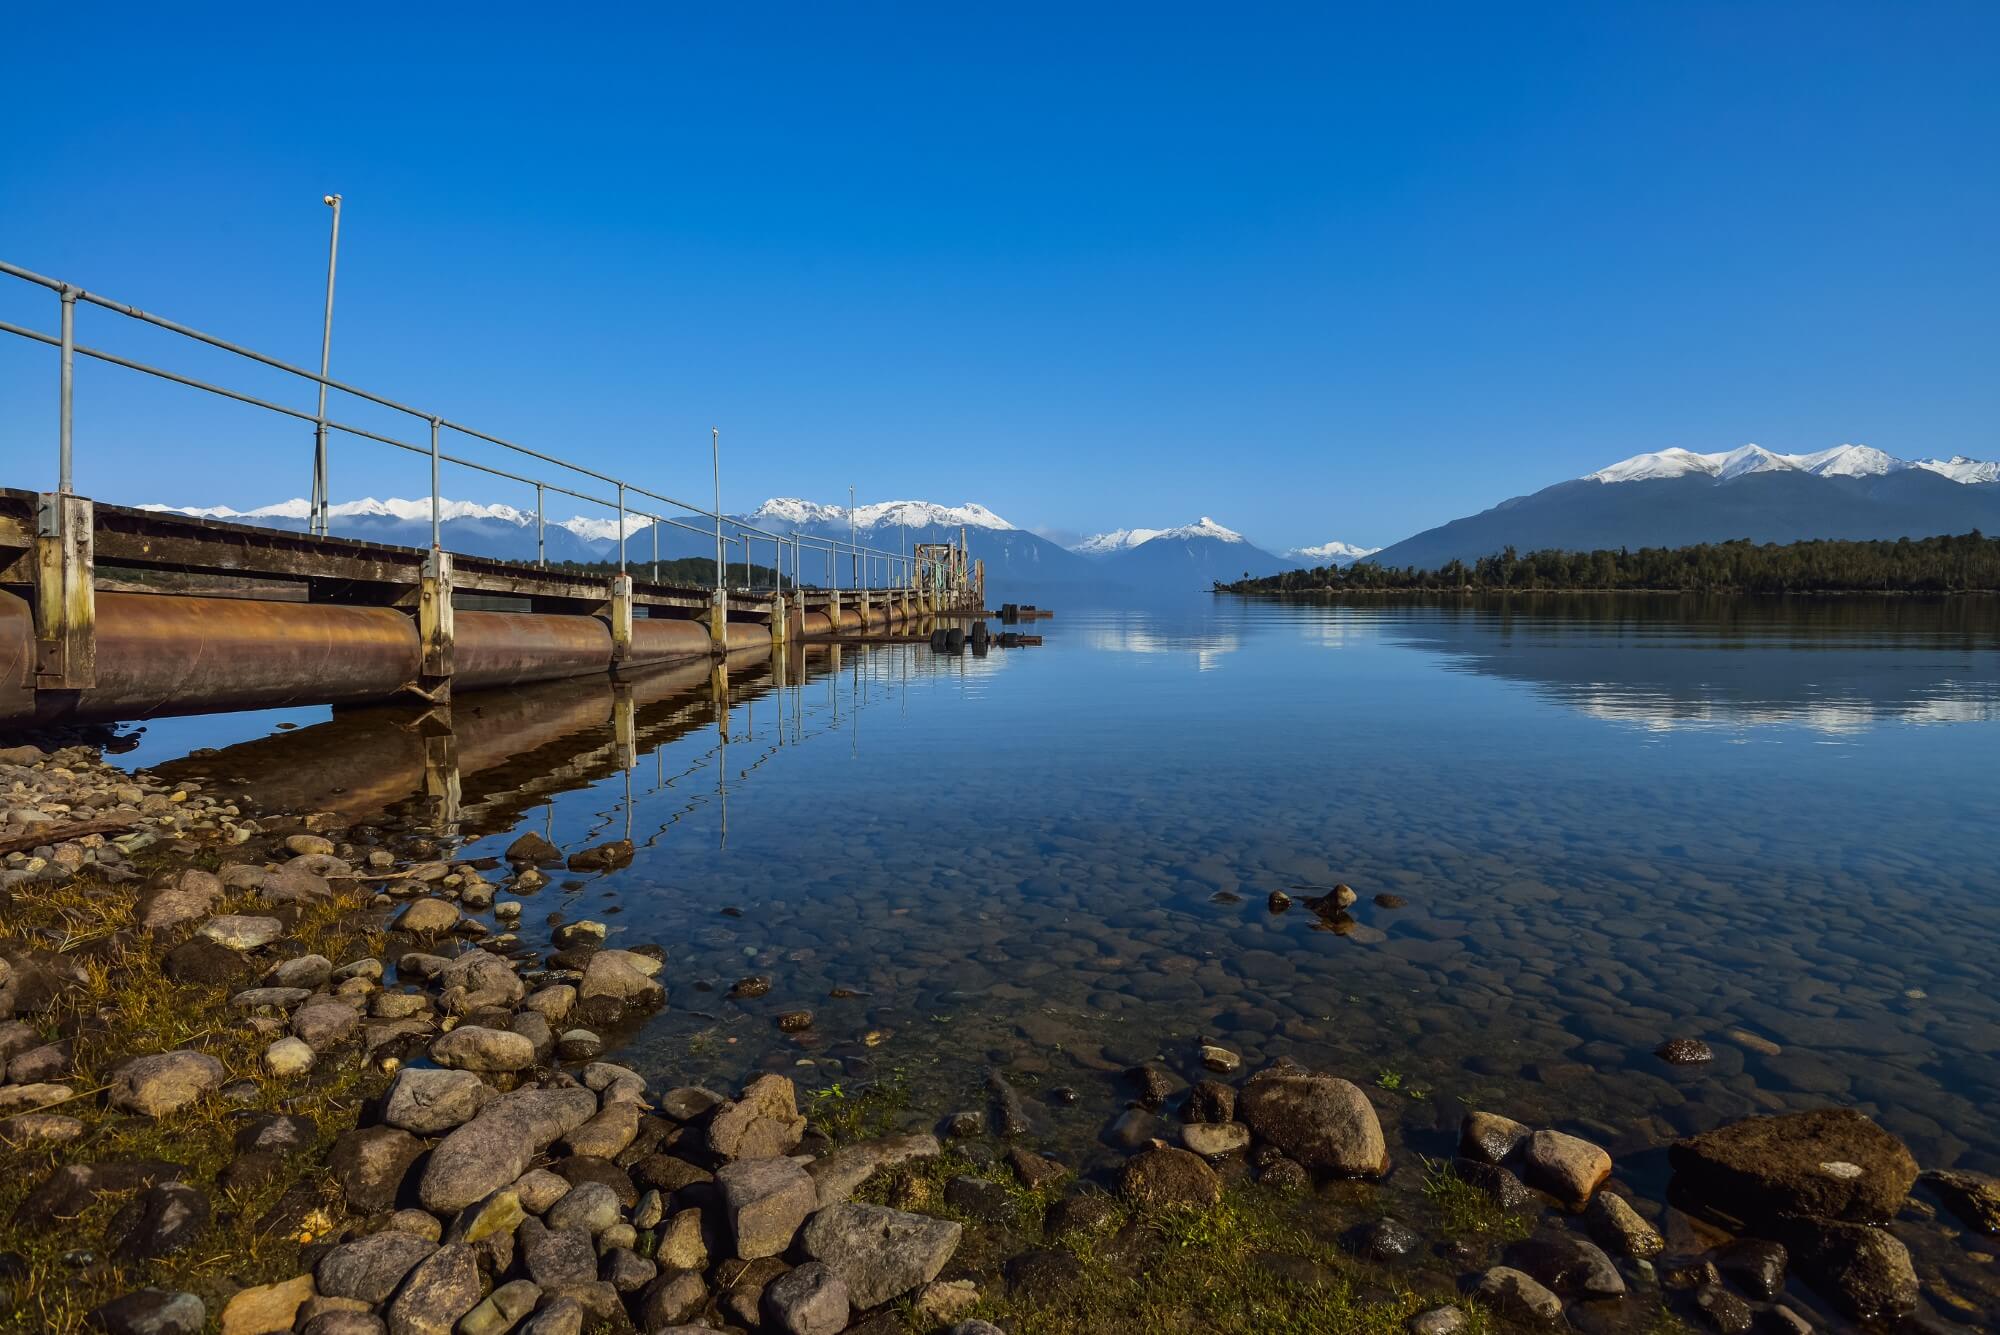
[1216,530,2000,594]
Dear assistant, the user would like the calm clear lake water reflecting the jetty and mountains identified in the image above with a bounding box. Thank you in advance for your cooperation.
[132,592,2000,1327]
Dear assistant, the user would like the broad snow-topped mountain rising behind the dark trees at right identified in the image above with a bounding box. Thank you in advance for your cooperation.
[1368,446,2000,570]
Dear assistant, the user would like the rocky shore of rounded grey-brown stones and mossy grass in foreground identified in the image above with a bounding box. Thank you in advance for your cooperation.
[0,747,2000,1335]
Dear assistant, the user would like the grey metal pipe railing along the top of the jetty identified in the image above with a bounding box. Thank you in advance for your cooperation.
[0,262,948,600]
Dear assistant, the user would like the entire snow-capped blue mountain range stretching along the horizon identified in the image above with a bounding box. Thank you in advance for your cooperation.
[146,437,2000,598]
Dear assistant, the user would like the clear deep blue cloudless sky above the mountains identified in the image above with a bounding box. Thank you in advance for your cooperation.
[0,2,2000,548]
